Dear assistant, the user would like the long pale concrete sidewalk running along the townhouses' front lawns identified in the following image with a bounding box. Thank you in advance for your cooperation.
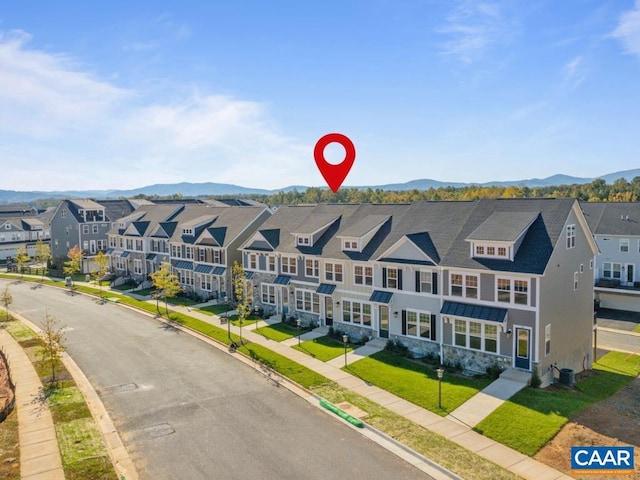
[161,307,572,480]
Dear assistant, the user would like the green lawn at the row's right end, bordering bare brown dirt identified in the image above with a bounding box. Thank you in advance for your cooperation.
[475,352,640,455]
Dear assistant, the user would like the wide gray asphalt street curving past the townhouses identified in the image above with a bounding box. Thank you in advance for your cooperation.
[0,279,429,480]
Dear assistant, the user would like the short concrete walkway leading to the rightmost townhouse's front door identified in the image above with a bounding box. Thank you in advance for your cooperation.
[447,368,531,428]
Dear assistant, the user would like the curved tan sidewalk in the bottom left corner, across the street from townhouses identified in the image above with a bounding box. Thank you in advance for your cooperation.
[0,330,64,480]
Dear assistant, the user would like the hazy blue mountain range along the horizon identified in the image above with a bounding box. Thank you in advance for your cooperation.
[0,168,640,203]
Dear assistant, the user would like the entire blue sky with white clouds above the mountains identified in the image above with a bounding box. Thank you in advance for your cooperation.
[0,0,640,190]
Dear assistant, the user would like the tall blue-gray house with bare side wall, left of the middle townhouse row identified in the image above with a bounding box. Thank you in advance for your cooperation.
[50,199,142,273]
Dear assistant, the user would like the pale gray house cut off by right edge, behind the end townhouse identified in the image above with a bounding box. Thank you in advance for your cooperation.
[581,202,640,312]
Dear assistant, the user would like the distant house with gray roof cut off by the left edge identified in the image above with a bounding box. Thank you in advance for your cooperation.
[0,204,50,262]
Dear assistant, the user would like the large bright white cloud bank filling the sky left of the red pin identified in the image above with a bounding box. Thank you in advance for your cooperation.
[0,32,310,190]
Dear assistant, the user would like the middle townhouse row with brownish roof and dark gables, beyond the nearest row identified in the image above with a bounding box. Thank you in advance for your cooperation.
[107,202,271,299]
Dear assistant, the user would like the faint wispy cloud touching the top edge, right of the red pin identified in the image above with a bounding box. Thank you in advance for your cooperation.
[438,0,505,64]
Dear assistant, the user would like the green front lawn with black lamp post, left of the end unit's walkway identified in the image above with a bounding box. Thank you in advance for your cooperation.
[344,350,491,416]
